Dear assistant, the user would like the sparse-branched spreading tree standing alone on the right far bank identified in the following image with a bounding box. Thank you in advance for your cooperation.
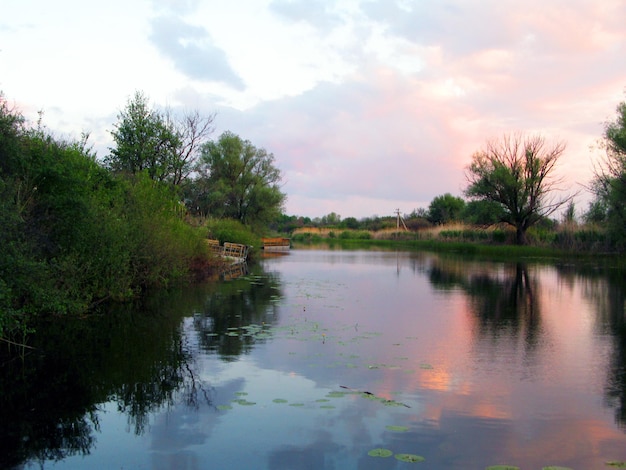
[465,134,572,245]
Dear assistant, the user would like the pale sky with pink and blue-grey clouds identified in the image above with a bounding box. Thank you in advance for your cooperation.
[0,0,626,218]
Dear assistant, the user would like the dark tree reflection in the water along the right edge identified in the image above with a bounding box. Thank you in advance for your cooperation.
[572,266,626,429]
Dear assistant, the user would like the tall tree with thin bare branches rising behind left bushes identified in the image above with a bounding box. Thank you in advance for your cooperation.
[105,92,214,186]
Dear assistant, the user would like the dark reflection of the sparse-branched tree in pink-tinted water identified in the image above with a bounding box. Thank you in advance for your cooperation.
[429,259,542,358]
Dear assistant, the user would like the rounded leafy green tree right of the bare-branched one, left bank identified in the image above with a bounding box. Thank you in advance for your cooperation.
[189,132,286,225]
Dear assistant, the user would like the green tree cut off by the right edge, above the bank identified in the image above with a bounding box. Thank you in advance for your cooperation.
[590,97,626,249]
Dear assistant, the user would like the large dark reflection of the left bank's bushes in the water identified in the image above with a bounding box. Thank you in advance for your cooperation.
[0,266,279,468]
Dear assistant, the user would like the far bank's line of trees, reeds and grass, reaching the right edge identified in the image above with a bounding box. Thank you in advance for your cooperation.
[273,94,626,252]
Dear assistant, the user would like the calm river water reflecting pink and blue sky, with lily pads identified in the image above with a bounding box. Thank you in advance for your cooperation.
[0,249,626,469]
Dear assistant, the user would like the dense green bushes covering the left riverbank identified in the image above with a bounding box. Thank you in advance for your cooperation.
[0,101,208,337]
